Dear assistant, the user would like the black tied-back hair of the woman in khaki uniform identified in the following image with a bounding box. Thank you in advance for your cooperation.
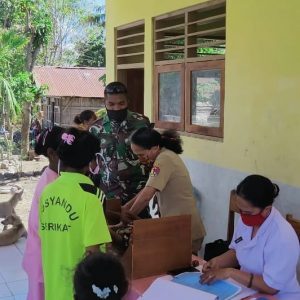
[131,127,183,154]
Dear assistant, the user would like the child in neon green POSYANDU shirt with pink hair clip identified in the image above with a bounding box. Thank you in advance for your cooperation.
[39,128,111,300]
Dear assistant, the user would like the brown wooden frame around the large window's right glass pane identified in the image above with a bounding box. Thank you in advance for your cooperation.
[185,60,225,138]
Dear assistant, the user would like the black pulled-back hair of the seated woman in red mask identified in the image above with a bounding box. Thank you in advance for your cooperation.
[236,175,280,208]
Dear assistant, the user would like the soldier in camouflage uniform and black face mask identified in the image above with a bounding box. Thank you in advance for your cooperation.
[90,82,150,218]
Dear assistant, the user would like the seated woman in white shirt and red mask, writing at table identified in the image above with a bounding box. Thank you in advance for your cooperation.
[201,175,300,299]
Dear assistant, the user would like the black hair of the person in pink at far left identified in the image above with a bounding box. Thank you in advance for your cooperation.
[34,126,65,157]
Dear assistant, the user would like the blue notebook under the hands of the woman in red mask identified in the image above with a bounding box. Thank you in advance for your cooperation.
[172,272,242,300]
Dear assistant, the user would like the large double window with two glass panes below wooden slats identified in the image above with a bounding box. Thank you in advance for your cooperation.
[154,0,226,138]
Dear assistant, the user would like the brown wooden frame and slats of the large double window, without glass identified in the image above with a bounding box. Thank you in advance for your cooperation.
[152,0,227,140]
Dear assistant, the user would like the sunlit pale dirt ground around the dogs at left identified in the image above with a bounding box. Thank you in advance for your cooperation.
[0,156,48,228]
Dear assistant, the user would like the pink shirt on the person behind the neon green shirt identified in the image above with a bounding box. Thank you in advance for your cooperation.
[23,167,58,282]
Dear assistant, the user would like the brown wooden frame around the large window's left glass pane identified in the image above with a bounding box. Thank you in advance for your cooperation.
[154,63,185,131]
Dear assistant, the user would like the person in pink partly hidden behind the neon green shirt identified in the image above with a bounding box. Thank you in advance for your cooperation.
[23,126,63,300]
